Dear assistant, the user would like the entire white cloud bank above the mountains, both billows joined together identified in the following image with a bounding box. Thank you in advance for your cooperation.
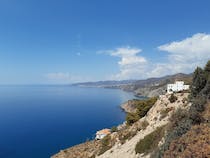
[105,33,210,80]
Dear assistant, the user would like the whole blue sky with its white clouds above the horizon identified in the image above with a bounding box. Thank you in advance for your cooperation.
[0,0,210,84]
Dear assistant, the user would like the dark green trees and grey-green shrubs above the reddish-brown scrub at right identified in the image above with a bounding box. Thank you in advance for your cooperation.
[157,61,210,158]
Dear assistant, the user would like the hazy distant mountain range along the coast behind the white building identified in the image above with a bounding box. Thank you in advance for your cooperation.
[73,73,192,97]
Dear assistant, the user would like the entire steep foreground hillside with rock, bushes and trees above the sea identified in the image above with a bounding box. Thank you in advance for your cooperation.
[52,61,210,158]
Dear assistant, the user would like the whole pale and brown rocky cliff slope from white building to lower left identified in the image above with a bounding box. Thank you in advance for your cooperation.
[52,93,190,158]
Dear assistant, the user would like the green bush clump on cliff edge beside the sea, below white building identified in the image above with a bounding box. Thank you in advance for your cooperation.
[126,97,157,125]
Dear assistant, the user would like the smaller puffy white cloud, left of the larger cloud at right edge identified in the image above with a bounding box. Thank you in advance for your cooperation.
[103,47,147,80]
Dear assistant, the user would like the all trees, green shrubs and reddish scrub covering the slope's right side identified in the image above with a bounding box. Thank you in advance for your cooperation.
[152,61,210,158]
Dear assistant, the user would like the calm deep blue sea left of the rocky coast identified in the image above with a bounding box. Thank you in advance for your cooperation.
[0,86,138,158]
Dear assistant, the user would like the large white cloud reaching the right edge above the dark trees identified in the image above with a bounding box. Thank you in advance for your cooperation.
[156,33,210,73]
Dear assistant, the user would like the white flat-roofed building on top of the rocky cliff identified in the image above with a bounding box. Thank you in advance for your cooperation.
[167,81,190,93]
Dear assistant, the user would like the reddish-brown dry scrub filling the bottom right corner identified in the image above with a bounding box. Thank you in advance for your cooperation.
[164,124,210,158]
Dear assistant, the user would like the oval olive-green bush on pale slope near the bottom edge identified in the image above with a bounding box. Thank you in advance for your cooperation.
[135,127,164,154]
